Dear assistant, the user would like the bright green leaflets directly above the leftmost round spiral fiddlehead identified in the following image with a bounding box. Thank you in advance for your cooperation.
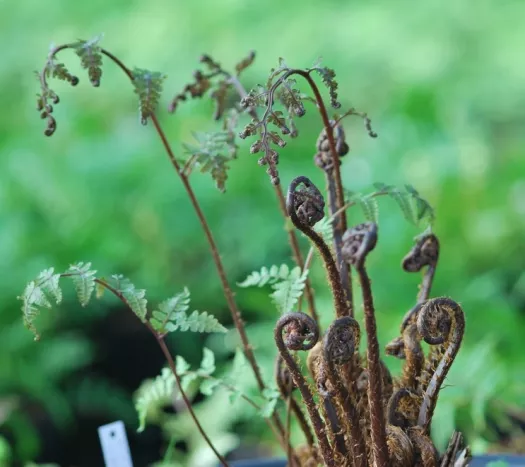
[238,264,308,313]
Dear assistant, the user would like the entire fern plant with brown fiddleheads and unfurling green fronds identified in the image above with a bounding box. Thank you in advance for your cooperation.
[20,38,478,467]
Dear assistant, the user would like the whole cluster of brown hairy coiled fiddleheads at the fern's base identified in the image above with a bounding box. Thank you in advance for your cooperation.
[275,177,468,467]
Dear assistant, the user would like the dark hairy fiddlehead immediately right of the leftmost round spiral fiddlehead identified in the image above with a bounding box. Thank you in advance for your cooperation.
[323,316,367,467]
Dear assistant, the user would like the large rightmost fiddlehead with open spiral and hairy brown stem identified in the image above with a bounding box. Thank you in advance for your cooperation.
[417,297,465,432]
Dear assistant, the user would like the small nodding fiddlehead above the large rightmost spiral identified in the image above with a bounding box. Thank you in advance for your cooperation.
[402,233,439,303]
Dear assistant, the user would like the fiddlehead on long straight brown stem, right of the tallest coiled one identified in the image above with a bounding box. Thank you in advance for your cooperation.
[342,222,389,467]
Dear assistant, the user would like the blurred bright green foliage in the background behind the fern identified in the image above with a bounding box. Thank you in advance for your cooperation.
[0,0,525,466]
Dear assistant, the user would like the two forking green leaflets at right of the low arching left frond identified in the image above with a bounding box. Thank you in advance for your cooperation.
[149,288,226,334]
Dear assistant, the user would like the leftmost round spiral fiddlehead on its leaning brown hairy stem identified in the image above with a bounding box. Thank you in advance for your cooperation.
[274,312,336,467]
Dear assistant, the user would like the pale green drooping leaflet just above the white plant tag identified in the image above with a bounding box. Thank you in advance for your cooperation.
[135,368,175,433]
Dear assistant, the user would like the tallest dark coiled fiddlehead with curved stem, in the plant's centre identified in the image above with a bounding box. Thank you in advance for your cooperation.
[286,176,349,318]
